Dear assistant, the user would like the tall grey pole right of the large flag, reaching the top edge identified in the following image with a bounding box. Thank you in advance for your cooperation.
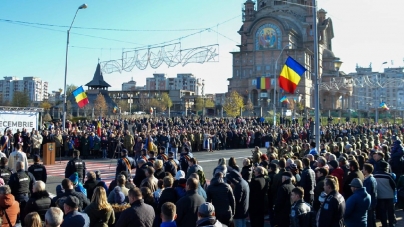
[313,0,320,151]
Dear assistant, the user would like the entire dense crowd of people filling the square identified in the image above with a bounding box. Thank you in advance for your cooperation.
[0,118,404,227]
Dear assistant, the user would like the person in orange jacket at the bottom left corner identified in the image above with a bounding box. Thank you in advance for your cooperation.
[0,185,20,227]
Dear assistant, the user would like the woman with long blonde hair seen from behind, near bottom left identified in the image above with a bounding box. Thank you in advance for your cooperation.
[84,186,115,227]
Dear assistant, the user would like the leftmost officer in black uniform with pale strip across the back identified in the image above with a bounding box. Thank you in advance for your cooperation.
[8,161,35,210]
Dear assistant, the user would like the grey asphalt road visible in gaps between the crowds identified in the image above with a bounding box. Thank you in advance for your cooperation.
[46,149,251,194]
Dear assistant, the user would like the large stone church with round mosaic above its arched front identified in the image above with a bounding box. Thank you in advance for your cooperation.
[228,0,348,113]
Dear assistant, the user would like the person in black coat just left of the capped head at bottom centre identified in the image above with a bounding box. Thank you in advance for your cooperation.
[175,178,205,227]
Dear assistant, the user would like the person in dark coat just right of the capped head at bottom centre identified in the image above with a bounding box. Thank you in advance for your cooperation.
[206,172,236,225]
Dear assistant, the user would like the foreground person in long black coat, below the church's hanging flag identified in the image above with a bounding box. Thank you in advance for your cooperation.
[248,166,268,227]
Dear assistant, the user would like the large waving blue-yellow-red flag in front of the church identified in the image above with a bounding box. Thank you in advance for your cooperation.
[279,57,307,93]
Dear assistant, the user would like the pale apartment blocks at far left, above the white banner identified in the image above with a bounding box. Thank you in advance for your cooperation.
[0,77,48,102]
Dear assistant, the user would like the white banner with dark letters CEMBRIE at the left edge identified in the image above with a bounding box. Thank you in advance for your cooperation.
[0,111,38,134]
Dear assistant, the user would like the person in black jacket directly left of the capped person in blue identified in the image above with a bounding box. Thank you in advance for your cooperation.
[317,176,345,227]
